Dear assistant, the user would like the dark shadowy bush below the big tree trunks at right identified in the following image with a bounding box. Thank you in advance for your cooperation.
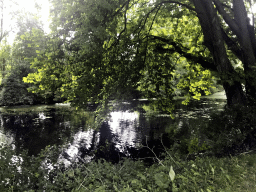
[203,103,256,155]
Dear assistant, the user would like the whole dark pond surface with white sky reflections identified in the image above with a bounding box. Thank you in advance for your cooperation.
[0,98,225,165]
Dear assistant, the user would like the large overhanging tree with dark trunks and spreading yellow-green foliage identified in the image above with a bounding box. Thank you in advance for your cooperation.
[25,0,256,106]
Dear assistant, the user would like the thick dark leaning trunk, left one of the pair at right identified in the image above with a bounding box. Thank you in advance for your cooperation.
[193,0,246,106]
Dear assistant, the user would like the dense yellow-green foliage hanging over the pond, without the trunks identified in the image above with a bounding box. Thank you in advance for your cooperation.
[24,1,214,109]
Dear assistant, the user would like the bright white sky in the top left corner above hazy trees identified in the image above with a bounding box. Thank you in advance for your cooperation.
[4,0,50,43]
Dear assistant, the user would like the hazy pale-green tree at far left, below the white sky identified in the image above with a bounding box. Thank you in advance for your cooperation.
[0,10,51,106]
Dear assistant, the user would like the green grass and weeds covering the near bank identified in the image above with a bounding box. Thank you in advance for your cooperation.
[0,145,256,192]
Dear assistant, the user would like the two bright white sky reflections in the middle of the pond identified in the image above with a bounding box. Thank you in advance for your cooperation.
[59,111,139,165]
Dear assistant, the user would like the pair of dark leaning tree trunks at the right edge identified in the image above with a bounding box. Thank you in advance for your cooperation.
[193,0,249,105]
